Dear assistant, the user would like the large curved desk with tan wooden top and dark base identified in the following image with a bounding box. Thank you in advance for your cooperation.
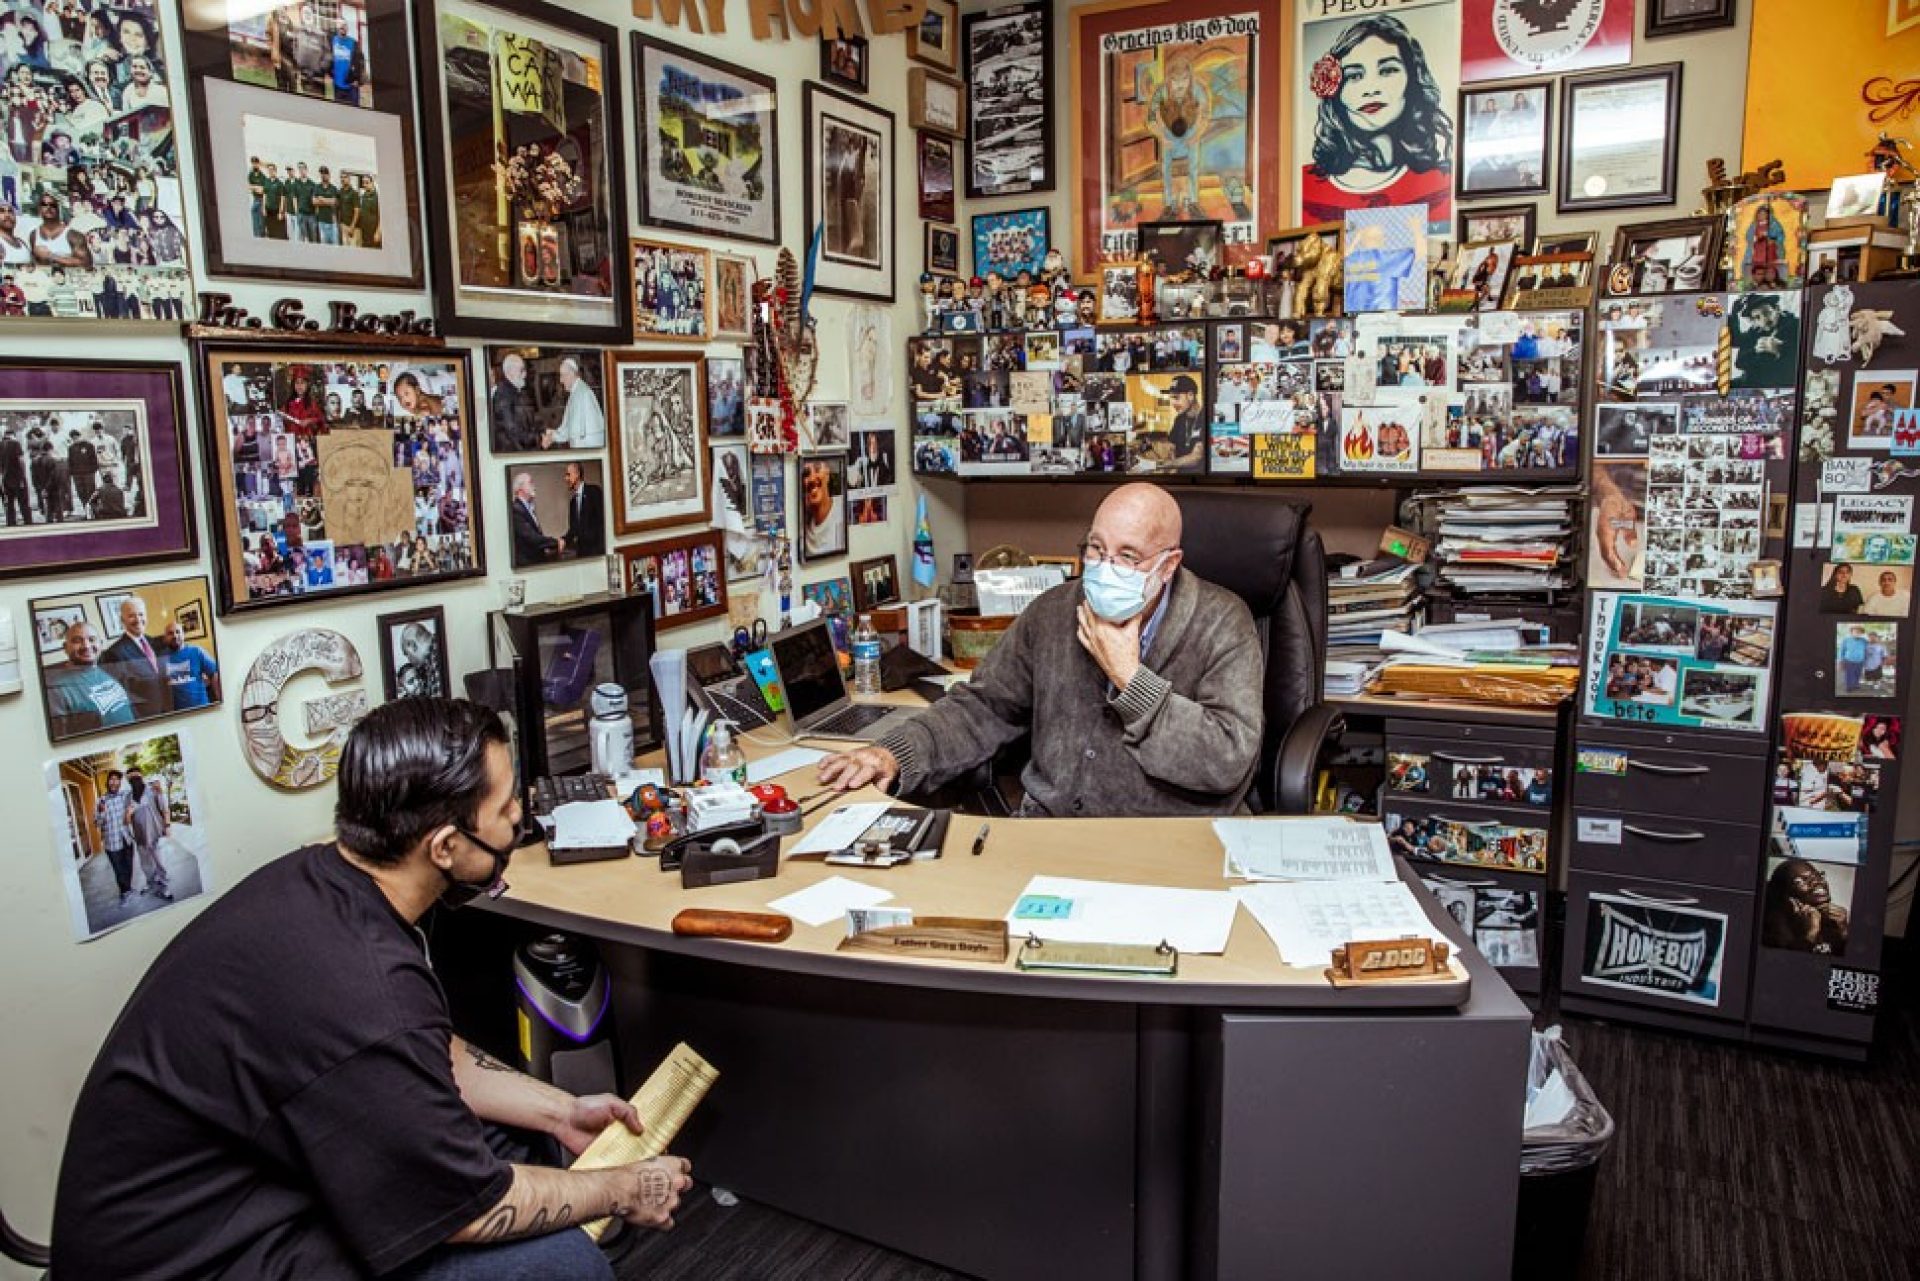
[456,718,1528,1281]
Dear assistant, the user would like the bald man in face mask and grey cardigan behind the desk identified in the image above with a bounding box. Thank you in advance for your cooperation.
[820,484,1261,818]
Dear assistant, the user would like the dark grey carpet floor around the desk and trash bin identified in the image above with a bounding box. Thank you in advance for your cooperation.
[616,941,1920,1281]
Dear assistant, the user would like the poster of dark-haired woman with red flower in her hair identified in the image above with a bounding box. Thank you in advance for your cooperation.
[1298,0,1459,236]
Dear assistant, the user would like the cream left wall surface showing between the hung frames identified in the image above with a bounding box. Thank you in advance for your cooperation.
[0,0,920,1277]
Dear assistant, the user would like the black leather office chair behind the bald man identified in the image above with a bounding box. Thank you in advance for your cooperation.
[1173,490,1340,814]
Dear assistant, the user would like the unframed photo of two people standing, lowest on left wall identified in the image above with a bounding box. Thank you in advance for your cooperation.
[44,732,211,943]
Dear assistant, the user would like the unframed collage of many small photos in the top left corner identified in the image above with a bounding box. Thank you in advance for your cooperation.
[0,0,194,323]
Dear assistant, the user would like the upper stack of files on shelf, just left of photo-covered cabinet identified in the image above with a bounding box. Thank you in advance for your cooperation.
[1415,486,1580,599]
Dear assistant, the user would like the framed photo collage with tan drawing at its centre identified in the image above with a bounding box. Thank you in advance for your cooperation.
[205,351,480,607]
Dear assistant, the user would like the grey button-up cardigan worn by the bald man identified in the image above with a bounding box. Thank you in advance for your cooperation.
[881,568,1261,818]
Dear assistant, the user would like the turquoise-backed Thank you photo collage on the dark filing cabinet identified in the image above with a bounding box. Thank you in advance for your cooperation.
[1582,592,1776,734]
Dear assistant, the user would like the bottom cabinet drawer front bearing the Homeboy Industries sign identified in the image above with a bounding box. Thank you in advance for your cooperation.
[1561,870,1753,1022]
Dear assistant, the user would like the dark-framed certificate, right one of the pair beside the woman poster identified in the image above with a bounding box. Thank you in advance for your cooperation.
[1557,61,1680,213]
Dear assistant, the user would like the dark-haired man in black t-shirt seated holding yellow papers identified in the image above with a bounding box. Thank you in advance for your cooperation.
[52,699,689,1281]
